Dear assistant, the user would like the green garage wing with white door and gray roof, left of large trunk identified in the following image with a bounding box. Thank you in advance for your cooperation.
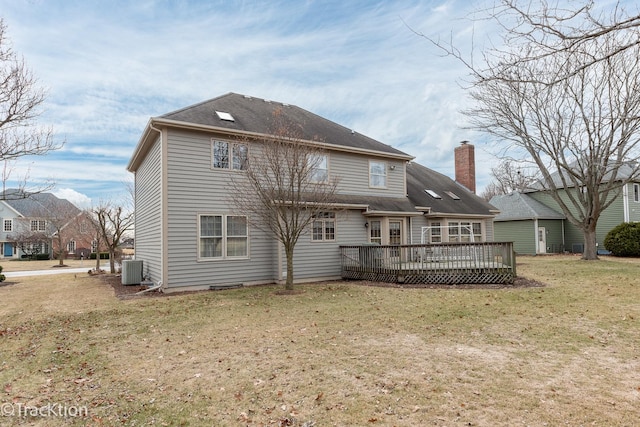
[489,192,566,255]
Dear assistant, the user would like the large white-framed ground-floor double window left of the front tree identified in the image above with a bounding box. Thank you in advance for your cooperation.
[198,215,249,259]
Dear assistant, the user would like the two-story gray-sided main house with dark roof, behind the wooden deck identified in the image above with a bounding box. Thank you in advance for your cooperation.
[128,93,494,292]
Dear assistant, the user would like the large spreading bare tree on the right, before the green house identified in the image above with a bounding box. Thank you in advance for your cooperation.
[422,0,640,259]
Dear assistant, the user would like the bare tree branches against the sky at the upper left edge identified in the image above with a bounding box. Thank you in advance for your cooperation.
[0,19,64,194]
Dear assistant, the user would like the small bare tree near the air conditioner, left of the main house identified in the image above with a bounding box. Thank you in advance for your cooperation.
[93,202,134,274]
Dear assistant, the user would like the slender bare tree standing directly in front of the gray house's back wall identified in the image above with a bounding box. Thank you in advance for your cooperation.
[231,110,338,290]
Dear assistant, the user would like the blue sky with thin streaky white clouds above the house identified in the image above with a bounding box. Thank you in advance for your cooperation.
[0,0,497,206]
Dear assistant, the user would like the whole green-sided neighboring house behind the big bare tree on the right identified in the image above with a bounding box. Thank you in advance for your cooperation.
[489,167,640,254]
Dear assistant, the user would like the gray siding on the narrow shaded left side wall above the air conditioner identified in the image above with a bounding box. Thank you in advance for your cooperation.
[135,138,163,283]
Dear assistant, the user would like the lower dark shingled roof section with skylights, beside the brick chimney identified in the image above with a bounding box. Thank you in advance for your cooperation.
[407,162,496,216]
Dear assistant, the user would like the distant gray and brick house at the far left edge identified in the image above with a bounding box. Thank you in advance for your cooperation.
[0,190,95,258]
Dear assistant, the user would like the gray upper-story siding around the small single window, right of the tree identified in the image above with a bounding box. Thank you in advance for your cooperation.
[329,152,406,197]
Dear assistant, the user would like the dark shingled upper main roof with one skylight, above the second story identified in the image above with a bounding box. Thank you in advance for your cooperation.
[157,93,413,159]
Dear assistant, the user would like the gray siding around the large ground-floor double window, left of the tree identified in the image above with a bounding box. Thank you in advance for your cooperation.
[166,130,276,288]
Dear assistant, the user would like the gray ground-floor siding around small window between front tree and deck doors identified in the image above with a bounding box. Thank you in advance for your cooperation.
[282,210,368,280]
